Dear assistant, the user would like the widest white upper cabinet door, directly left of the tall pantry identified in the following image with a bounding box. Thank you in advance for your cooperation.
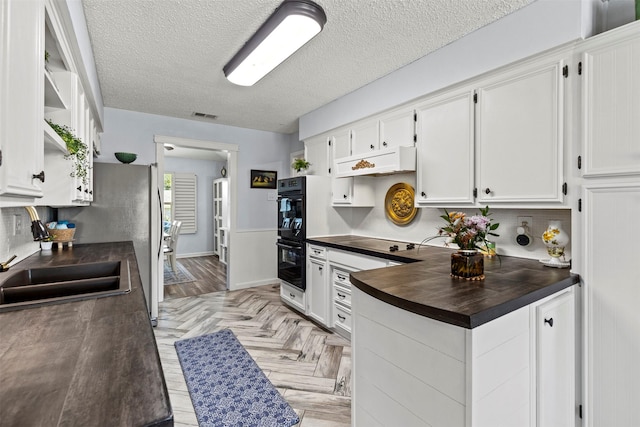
[476,61,564,204]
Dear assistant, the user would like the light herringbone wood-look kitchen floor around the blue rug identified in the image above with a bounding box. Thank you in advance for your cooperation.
[155,285,351,427]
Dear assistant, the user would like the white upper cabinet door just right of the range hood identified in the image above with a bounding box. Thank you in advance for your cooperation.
[416,89,475,205]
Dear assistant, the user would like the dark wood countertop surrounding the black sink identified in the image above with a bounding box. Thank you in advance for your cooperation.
[0,242,173,427]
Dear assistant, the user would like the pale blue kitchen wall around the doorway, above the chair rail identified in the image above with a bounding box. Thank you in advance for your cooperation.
[96,108,290,234]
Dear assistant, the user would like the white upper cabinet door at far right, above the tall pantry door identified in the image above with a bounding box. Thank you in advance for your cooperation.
[581,25,640,177]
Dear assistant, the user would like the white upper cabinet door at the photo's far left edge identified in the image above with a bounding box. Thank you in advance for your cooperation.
[0,0,45,201]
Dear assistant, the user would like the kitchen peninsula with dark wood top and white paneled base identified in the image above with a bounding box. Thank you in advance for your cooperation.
[308,236,579,427]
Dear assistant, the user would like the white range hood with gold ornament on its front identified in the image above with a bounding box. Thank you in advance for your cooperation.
[335,147,416,178]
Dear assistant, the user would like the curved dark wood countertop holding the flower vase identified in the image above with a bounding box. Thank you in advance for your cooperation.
[307,236,579,329]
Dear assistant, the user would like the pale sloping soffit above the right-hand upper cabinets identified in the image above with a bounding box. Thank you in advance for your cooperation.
[299,0,600,140]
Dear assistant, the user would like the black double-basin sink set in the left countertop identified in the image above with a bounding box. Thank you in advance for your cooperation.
[0,261,131,311]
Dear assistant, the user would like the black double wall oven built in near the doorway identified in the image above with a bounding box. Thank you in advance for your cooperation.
[276,176,306,291]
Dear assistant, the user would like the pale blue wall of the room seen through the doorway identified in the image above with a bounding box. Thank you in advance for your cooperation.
[164,157,226,257]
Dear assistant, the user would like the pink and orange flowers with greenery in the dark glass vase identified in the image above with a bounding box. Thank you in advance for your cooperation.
[421,206,500,250]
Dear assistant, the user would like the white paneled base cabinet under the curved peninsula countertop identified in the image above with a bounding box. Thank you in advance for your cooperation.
[351,288,576,427]
